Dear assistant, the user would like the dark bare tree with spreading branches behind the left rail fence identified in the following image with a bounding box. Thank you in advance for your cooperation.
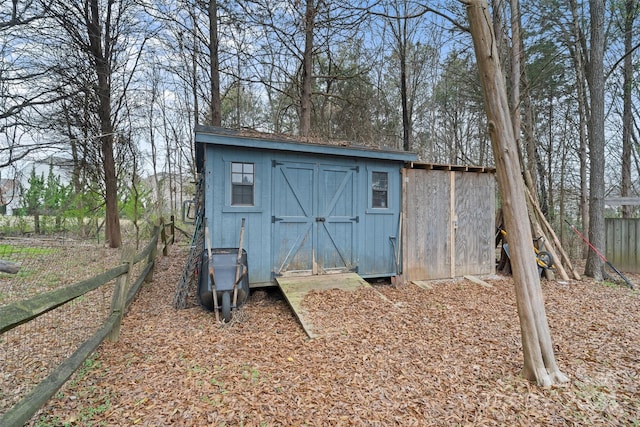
[51,0,145,248]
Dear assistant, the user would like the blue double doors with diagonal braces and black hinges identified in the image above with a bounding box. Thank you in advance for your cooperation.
[272,162,358,276]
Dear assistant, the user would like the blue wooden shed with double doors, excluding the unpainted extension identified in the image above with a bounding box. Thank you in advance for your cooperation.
[196,126,416,287]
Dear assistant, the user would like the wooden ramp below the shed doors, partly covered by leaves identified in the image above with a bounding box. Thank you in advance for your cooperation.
[276,273,370,338]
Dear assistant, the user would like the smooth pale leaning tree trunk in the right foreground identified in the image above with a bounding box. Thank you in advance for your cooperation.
[467,0,568,386]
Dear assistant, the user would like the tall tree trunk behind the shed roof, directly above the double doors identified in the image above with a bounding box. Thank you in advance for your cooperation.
[300,0,316,137]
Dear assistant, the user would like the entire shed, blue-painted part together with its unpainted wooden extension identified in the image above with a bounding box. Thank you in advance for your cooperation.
[196,126,495,287]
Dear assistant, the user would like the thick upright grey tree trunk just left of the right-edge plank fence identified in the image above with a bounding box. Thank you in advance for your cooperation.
[584,0,605,280]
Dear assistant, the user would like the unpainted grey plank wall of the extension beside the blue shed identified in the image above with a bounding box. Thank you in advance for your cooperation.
[403,169,495,280]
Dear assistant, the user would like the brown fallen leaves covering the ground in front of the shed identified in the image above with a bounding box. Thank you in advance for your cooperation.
[33,246,640,426]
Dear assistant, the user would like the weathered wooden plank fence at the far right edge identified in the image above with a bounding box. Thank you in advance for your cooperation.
[605,218,640,273]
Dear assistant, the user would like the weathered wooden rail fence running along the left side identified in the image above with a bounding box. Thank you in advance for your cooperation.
[0,216,175,426]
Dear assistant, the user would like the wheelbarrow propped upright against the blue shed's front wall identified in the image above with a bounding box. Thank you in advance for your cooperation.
[198,218,249,322]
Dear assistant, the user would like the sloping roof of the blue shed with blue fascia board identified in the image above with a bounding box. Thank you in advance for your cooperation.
[196,126,418,162]
